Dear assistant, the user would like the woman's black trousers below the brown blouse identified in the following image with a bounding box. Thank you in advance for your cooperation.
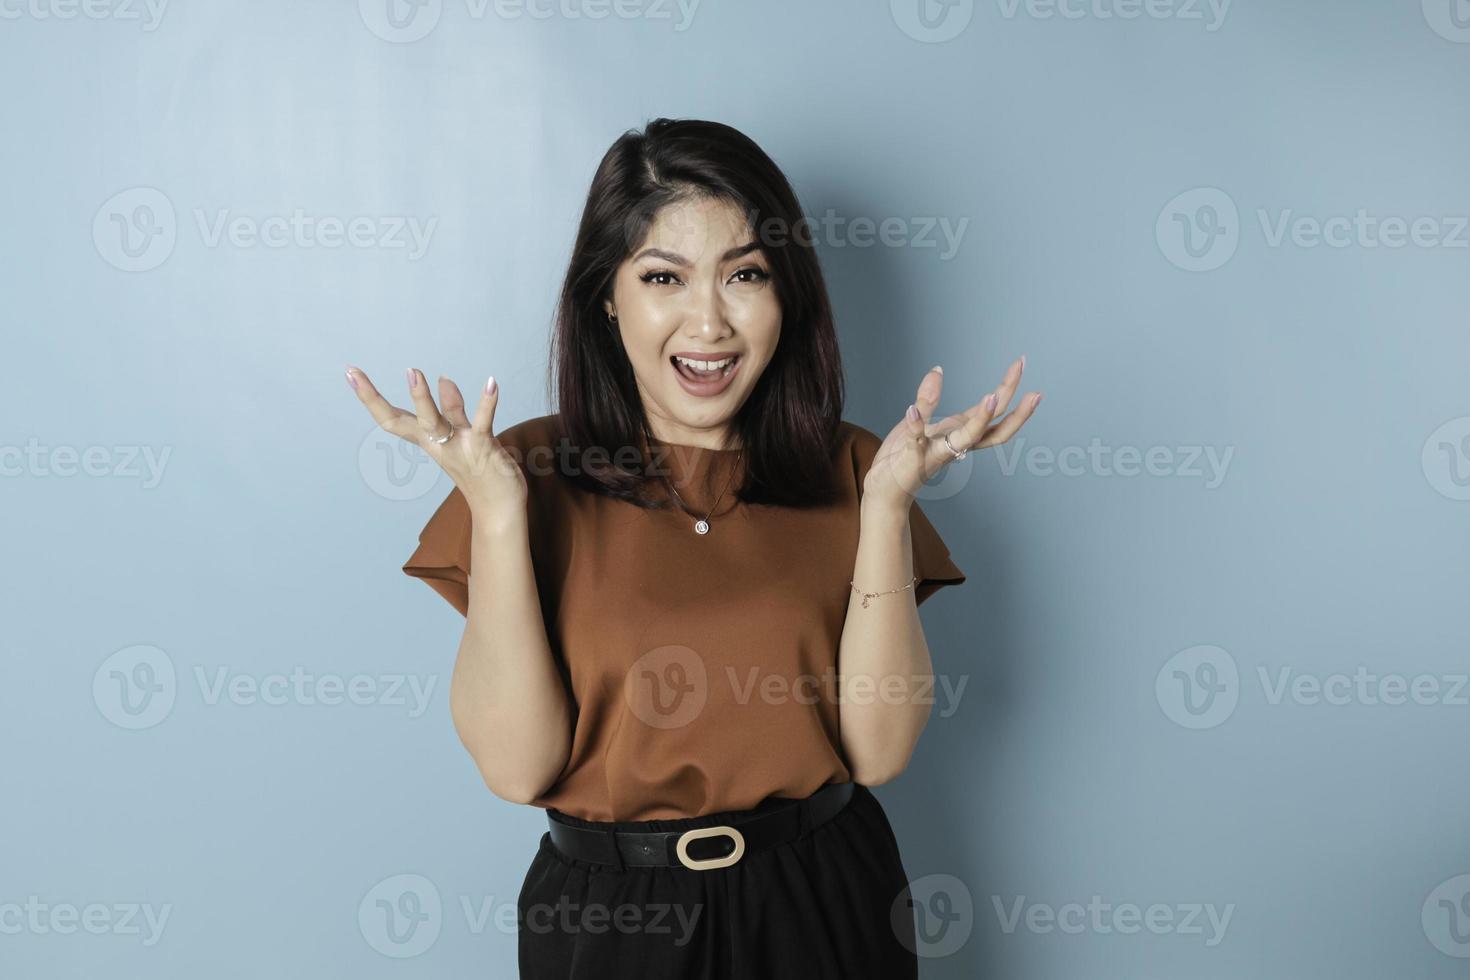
[517,786,919,980]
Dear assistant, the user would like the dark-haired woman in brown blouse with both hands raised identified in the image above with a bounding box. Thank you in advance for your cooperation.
[347,119,1039,980]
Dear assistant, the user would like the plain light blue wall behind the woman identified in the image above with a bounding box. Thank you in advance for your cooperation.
[0,0,1470,980]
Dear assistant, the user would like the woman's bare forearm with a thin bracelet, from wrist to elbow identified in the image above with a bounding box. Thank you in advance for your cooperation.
[838,505,933,786]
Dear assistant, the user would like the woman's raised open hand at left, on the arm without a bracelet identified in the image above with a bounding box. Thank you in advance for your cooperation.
[347,367,526,523]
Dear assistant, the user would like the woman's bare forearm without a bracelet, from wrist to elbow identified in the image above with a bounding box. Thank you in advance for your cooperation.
[450,520,572,802]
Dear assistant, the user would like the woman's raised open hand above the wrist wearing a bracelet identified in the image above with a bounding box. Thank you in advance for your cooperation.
[863,357,1041,516]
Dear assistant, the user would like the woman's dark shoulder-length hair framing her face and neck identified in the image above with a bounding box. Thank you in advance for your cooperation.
[548,119,844,507]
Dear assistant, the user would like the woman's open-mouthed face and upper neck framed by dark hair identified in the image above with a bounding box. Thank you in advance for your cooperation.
[606,197,781,448]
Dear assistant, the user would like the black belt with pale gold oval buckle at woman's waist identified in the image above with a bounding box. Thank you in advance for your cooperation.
[547,783,853,871]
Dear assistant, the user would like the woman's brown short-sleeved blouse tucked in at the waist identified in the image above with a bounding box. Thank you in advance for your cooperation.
[403,414,964,820]
